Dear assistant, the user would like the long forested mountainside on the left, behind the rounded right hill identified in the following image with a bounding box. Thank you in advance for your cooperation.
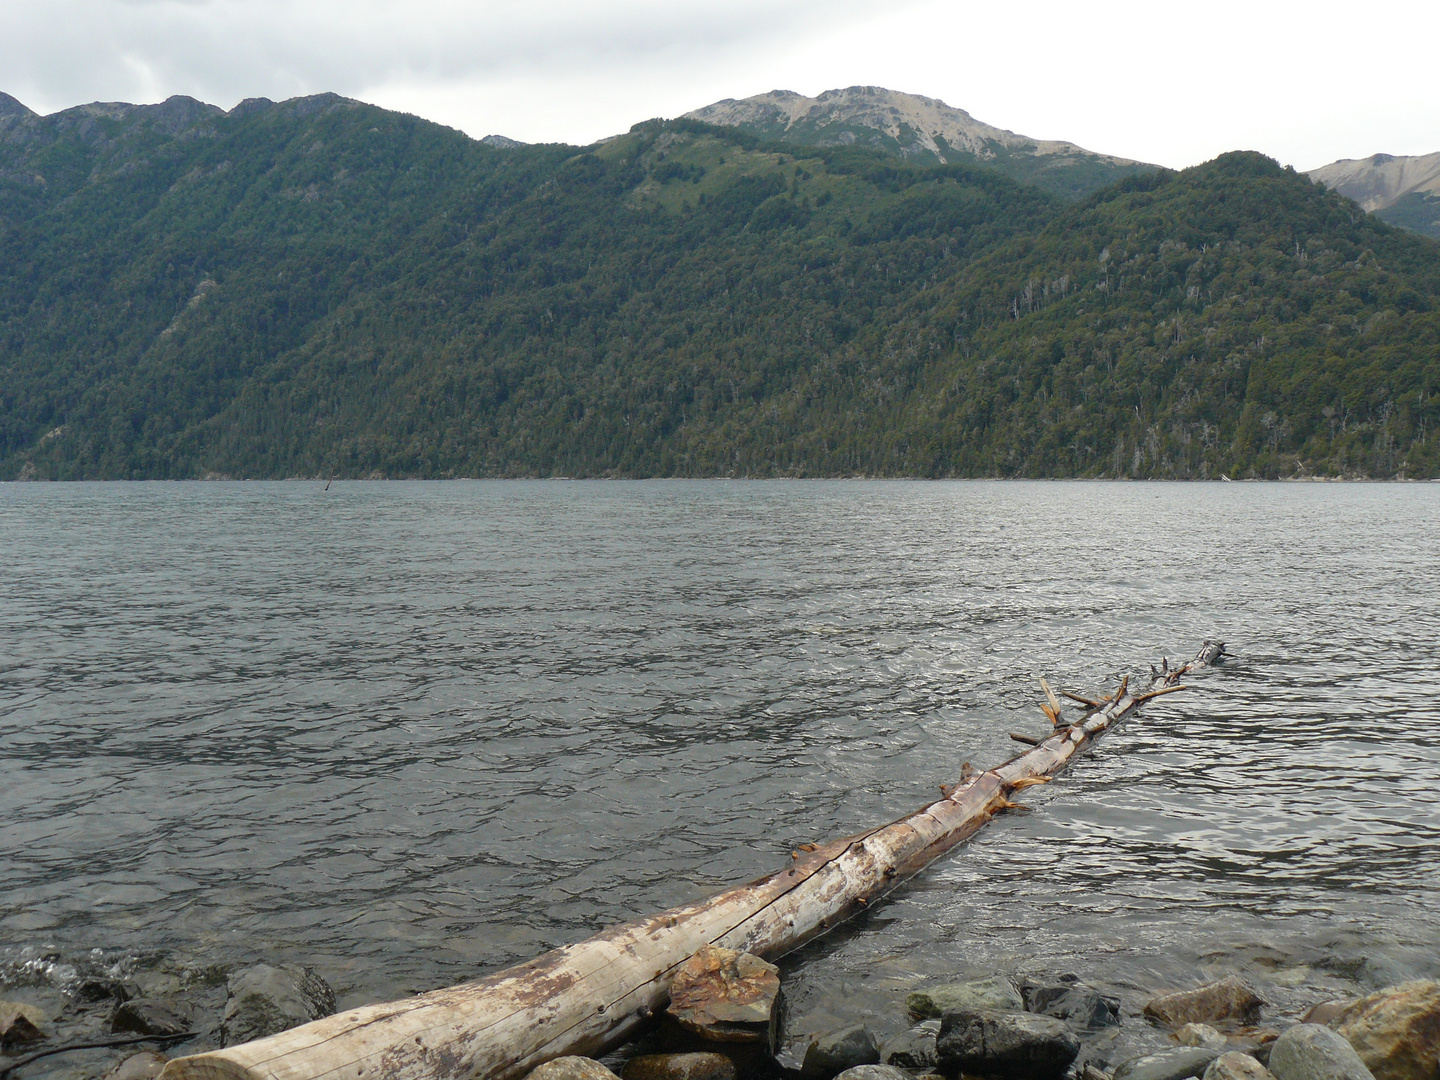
[0,96,1057,477]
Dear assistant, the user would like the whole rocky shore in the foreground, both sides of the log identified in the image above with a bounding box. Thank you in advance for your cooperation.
[0,949,1440,1080]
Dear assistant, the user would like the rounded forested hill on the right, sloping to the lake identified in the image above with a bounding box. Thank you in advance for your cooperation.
[887,154,1440,478]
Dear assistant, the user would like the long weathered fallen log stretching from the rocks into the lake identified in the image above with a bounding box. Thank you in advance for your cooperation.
[161,642,1224,1080]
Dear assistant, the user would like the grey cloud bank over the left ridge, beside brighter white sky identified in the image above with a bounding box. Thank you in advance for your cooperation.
[0,0,874,111]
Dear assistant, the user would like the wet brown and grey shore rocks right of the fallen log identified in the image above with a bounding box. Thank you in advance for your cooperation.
[528,950,1440,1080]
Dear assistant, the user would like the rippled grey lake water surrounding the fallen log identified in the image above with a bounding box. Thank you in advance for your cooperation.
[0,481,1440,1071]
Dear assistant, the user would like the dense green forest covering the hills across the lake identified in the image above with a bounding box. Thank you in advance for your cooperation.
[0,95,1440,478]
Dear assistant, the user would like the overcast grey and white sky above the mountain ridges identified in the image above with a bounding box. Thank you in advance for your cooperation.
[0,0,1440,168]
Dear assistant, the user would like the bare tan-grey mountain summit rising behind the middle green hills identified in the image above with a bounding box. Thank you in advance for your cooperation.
[685,86,1155,197]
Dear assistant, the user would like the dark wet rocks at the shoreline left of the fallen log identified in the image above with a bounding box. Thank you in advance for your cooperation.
[0,963,336,1080]
